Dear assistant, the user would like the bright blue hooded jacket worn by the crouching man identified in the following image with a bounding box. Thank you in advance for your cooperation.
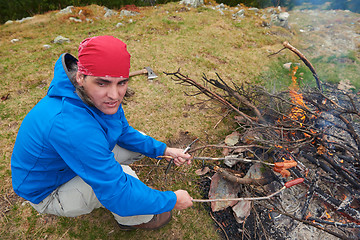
[11,54,176,216]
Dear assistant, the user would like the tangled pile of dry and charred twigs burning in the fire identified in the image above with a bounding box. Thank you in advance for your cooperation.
[165,43,360,239]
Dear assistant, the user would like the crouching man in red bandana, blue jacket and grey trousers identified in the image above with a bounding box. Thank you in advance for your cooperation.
[11,36,192,230]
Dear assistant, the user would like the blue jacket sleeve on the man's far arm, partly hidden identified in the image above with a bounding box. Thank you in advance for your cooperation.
[117,108,166,158]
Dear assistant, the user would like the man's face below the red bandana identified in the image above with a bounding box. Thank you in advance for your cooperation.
[76,73,129,114]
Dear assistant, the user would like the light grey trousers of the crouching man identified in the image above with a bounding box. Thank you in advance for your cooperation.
[30,145,153,226]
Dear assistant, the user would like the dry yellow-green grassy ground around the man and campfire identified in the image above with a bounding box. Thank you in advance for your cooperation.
[0,1,360,239]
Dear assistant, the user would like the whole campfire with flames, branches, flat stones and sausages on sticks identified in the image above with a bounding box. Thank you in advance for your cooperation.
[166,42,360,239]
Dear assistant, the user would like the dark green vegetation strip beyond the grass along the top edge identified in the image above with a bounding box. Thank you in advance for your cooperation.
[0,0,360,23]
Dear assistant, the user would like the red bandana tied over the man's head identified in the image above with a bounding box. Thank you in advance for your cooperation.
[77,36,130,78]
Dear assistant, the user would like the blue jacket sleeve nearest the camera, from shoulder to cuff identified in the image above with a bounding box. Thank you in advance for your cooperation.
[49,104,176,216]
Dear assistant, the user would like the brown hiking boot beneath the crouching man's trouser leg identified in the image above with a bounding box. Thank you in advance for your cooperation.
[118,211,171,231]
